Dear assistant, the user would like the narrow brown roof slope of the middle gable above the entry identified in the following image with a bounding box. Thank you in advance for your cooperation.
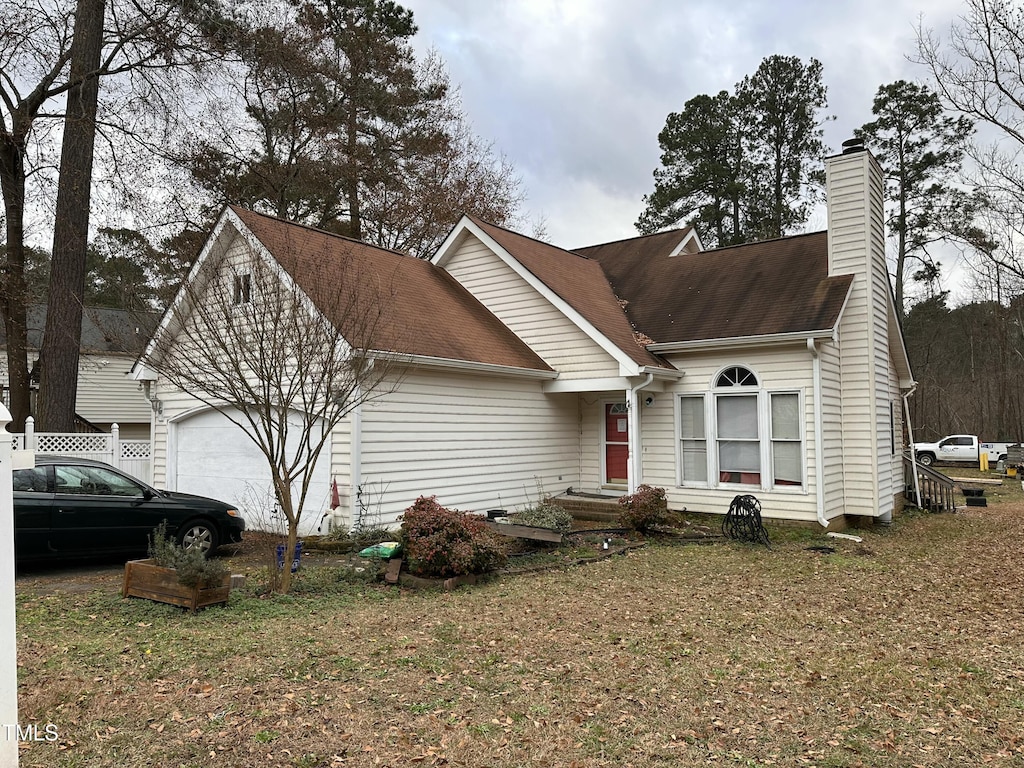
[469,216,671,368]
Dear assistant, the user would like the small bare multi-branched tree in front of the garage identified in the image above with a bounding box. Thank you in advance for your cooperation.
[135,222,402,592]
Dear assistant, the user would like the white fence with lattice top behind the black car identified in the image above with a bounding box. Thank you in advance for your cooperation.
[11,416,153,482]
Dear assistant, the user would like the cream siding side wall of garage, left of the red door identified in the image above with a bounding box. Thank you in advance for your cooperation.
[361,370,580,524]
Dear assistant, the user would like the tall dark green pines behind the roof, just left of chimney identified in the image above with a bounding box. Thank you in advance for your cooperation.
[637,55,826,246]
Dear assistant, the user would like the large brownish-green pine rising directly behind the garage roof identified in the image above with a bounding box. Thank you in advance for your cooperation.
[177,0,520,255]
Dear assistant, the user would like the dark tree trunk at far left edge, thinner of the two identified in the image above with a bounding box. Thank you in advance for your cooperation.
[0,135,32,432]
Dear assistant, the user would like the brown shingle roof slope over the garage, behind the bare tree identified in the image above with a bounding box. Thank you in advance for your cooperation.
[230,206,551,371]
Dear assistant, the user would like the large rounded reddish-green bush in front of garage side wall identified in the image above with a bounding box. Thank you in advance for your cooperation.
[400,496,507,579]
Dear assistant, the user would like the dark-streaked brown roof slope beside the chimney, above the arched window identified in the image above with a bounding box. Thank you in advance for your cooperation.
[578,232,853,343]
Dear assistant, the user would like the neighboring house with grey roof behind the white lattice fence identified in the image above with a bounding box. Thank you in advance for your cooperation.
[0,304,159,439]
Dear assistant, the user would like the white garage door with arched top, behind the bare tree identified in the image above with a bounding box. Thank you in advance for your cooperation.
[168,411,331,536]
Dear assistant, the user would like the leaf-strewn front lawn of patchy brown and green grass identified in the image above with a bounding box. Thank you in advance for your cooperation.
[17,479,1024,768]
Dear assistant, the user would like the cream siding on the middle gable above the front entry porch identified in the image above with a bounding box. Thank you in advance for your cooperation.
[444,236,618,379]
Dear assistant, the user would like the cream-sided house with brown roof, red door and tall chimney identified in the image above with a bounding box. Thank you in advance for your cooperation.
[135,141,914,530]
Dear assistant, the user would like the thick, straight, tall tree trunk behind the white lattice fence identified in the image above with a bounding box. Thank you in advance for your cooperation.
[37,0,105,432]
